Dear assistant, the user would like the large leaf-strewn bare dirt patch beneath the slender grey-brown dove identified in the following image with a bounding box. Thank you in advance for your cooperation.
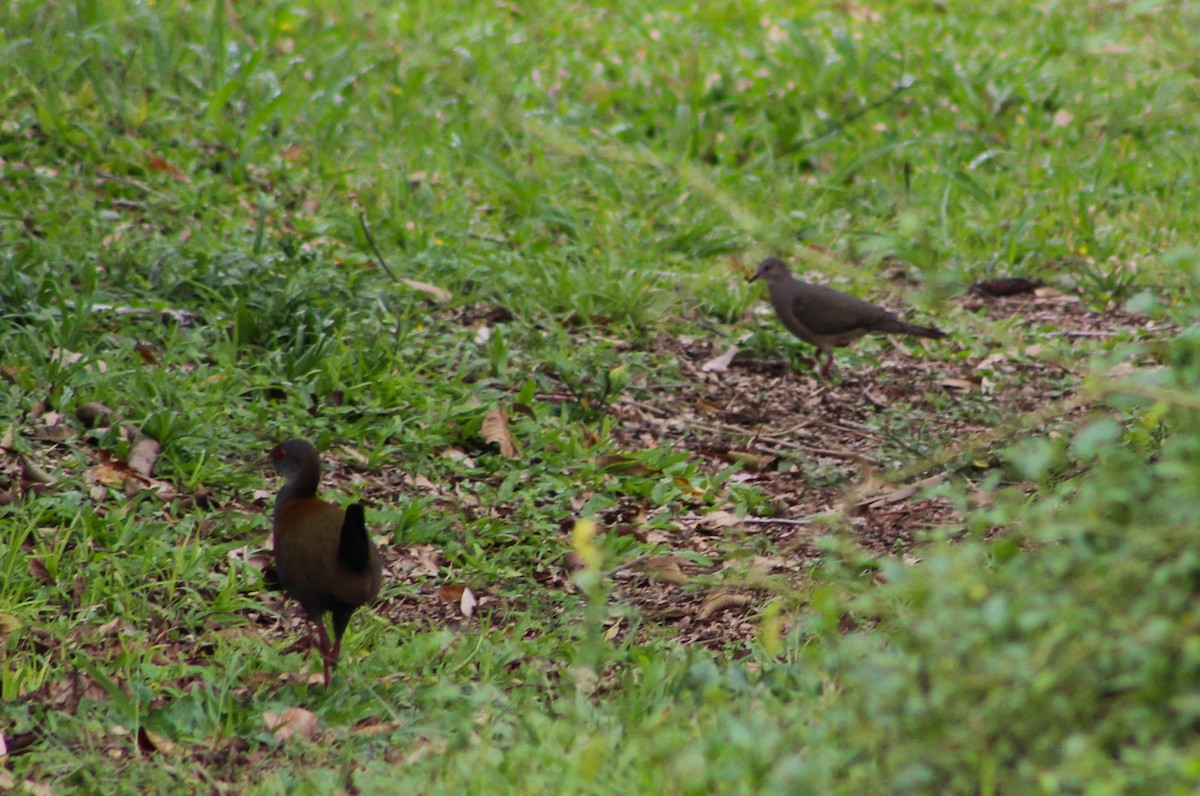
[559,288,1170,650]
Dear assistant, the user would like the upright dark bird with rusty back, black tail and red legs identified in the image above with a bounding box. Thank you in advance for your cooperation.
[269,439,383,688]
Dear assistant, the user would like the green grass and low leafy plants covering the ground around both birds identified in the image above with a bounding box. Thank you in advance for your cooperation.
[0,0,1200,794]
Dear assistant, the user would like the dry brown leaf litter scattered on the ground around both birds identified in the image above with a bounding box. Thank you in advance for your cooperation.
[0,288,1164,755]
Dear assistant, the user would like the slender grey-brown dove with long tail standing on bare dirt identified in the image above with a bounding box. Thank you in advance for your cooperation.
[746,257,946,379]
